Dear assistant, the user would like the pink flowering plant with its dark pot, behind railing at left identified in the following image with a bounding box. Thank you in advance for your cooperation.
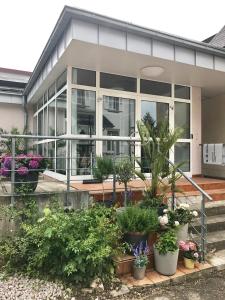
[0,154,48,193]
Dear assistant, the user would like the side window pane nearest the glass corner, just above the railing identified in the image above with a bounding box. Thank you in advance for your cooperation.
[56,91,67,135]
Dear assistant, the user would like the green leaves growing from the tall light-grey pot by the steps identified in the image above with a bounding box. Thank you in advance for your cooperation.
[155,230,178,254]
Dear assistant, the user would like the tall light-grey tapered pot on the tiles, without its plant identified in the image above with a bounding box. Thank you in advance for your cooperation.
[153,245,179,276]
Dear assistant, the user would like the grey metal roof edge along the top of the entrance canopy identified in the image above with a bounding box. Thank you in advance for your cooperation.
[25,6,225,95]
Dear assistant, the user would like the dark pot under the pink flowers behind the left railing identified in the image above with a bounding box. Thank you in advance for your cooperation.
[15,172,39,193]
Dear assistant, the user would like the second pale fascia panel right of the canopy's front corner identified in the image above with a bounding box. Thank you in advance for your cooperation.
[99,26,126,50]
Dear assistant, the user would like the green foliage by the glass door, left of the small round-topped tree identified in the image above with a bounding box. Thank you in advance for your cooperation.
[93,156,113,181]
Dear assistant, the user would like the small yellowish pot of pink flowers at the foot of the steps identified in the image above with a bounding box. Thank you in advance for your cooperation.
[179,241,200,269]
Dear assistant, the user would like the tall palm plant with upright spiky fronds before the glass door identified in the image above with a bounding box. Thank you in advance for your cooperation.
[135,121,182,202]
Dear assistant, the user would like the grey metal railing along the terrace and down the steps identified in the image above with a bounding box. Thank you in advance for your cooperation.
[1,134,212,261]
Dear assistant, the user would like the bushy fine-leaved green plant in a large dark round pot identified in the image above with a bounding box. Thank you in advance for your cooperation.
[117,206,159,247]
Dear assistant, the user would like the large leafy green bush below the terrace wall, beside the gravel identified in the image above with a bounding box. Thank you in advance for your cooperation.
[0,206,120,283]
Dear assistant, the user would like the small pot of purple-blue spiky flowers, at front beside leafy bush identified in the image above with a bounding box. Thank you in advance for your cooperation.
[133,242,149,280]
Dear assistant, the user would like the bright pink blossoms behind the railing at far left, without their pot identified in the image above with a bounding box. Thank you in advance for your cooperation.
[0,154,48,177]
